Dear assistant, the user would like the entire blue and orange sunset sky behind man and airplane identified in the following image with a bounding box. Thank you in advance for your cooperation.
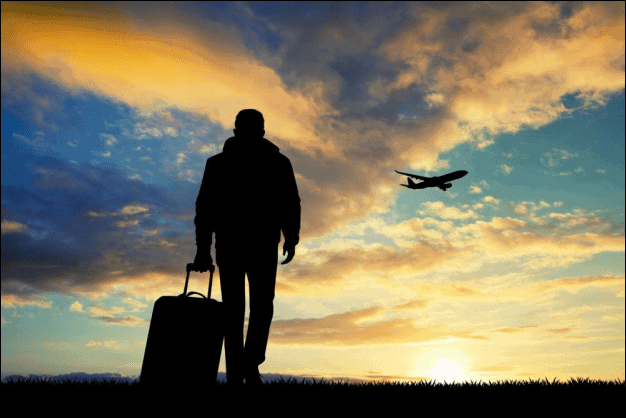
[1,2,625,382]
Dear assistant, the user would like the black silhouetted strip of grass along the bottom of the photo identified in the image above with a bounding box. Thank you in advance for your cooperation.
[1,378,626,416]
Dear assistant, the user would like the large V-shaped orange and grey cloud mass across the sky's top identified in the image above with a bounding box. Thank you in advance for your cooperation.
[2,3,624,245]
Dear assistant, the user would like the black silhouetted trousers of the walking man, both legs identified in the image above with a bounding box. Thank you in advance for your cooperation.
[216,244,278,381]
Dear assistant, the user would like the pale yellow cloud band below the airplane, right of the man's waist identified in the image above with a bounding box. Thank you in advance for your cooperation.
[279,211,624,290]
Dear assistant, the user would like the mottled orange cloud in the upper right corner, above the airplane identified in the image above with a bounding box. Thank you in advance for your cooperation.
[380,2,624,145]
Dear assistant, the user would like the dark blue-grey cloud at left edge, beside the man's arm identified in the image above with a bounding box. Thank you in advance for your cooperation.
[1,153,190,305]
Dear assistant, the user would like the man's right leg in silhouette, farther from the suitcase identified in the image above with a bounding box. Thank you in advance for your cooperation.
[245,247,278,373]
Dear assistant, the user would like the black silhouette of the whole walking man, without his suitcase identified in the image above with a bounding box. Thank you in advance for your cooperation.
[194,109,301,384]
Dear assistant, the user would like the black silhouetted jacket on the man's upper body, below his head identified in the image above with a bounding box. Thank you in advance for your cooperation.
[194,137,301,250]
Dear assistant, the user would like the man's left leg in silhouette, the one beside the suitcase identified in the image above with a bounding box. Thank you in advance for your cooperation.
[219,263,246,383]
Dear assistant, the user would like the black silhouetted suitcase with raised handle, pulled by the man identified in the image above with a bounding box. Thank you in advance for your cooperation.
[139,263,224,388]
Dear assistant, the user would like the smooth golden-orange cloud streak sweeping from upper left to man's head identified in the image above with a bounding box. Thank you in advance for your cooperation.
[2,2,332,152]
